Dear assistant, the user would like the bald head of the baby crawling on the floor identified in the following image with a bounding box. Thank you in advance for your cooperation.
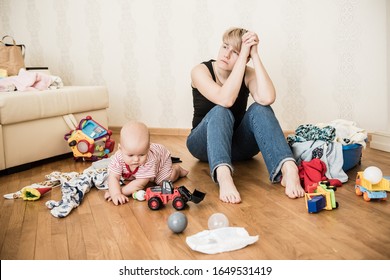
[119,121,150,167]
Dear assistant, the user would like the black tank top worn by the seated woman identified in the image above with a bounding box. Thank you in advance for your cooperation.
[192,59,249,129]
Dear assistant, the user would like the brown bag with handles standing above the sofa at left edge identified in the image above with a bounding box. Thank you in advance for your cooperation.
[0,35,25,76]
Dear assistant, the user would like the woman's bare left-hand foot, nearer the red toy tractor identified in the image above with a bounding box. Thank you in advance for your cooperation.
[216,166,241,203]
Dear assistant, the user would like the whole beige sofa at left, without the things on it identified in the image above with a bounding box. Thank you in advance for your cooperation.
[0,86,109,172]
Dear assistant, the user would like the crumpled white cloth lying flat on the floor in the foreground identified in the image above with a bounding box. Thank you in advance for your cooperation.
[186,227,259,254]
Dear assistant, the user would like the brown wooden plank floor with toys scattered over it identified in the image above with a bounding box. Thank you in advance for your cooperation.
[0,133,390,260]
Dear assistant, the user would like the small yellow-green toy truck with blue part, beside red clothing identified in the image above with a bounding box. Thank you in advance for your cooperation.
[305,181,339,213]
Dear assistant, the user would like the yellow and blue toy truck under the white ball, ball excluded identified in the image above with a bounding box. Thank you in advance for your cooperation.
[355,171,390,201]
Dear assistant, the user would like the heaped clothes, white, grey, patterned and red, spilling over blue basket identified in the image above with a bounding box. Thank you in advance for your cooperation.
[287,119,367,189]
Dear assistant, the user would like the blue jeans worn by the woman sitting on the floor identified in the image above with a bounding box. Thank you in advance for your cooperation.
[187,103,295,182]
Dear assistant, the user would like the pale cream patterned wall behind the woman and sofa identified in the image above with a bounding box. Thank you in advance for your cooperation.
[0,0,390,132]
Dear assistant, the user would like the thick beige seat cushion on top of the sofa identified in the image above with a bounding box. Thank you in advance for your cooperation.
[0,86,109,125]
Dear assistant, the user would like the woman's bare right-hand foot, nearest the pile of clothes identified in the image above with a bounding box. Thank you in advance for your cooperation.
[281,160,305,198]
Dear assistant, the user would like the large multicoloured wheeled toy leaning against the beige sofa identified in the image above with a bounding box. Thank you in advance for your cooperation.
[64,116,115,161]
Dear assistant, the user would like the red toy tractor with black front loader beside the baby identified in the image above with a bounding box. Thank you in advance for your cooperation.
[145,180,206,210]
